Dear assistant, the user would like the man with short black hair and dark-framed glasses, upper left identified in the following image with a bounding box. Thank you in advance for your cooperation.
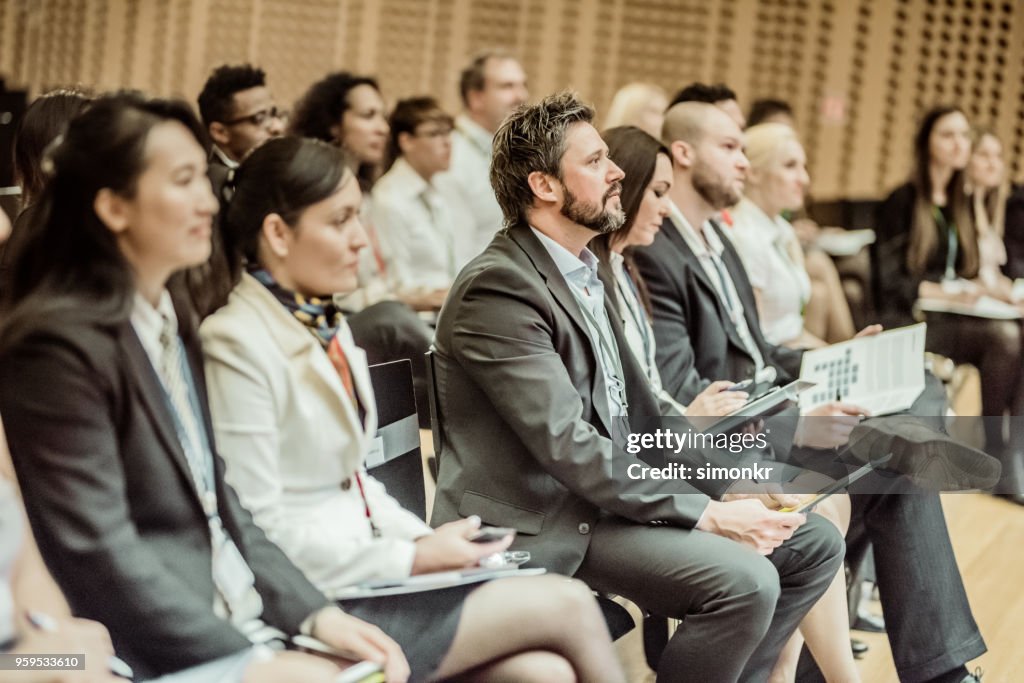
[199,65,287,199]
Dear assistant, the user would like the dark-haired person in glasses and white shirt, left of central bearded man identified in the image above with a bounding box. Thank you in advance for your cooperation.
[371,97,477,307]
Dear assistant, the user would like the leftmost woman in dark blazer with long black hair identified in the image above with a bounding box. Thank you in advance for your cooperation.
[0,94,408,681]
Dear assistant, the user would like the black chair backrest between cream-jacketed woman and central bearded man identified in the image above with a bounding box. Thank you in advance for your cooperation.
[367,358,427,520]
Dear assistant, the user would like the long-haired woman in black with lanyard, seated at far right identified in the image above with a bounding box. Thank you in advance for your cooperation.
[872,106,1024,494]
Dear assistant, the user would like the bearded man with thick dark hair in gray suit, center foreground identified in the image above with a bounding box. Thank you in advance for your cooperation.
[431,93,842,681]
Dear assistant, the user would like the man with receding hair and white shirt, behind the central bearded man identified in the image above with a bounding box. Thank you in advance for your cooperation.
[450,51,529,253]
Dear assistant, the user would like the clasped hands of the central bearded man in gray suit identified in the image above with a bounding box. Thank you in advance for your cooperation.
[697,499,807,555]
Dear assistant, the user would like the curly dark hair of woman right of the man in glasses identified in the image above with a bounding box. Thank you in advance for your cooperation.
[289,72,381,189]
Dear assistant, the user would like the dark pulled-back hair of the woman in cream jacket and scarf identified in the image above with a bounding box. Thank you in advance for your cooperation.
[220,137,347,288]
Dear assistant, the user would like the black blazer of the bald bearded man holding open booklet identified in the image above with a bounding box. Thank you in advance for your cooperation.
[634,218,803,405]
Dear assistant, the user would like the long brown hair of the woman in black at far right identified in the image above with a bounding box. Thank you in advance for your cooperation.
[906,105,979,279]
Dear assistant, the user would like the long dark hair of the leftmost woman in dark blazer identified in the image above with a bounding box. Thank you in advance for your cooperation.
[2,92,205,339]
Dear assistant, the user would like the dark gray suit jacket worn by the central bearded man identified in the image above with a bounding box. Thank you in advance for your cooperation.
[432,225,734,574]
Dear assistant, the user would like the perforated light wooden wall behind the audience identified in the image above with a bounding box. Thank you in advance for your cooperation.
[0,0,1024,199]
